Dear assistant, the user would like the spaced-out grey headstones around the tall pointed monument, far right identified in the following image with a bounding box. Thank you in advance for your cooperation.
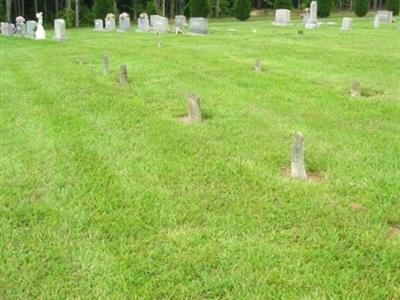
[272,1,393,30]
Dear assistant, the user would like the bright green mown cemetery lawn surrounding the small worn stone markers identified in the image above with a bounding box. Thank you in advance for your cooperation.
[0,16,400,299]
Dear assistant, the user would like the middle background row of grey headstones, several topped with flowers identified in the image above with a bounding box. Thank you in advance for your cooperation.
[94,13,208,34]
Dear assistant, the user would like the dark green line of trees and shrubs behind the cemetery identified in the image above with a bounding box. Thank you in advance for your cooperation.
[0,0,400,26]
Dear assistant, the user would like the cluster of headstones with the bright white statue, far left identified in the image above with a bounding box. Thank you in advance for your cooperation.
[0,12,67,41]
